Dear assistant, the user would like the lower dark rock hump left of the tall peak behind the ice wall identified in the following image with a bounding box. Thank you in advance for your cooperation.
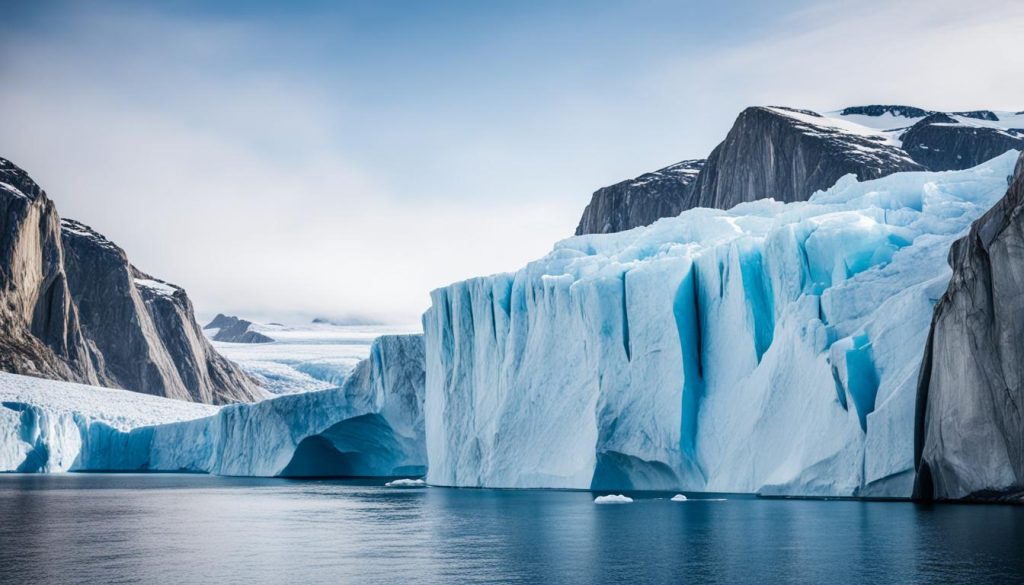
[575,160,705,236]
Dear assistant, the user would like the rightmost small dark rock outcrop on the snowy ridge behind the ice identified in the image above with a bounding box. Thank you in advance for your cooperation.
[900,112,1024,171]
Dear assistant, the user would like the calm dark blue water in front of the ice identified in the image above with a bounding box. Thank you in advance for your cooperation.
[0,474,1024,585]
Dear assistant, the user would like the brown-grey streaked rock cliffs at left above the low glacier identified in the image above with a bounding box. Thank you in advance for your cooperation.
[0,159,261,404]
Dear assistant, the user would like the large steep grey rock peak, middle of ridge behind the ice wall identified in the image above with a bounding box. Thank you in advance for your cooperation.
[683,108,924,209]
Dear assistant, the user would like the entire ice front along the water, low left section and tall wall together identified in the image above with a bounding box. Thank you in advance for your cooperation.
[0,153,1016,497]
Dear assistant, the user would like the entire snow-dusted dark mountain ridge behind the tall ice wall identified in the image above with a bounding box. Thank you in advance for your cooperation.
[575,106,1024,236]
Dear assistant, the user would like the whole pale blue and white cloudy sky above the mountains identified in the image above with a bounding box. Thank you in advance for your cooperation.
[0,0,1024,323]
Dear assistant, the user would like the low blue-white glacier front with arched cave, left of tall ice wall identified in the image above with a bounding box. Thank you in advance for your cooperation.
[0,335,426,477]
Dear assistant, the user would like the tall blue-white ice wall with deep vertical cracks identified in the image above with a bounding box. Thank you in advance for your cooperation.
[424,153,1016,496]
